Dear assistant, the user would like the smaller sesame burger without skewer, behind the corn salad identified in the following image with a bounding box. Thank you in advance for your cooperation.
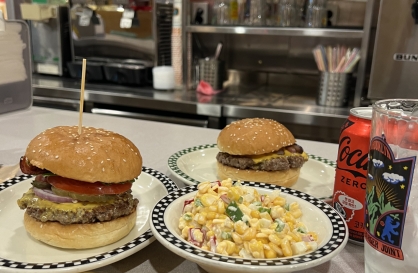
[216,118,308,187]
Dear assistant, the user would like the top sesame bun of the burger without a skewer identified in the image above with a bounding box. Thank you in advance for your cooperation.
[218,118,296,155]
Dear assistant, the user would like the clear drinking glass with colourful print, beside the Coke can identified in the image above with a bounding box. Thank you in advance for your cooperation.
[364,99,418,273]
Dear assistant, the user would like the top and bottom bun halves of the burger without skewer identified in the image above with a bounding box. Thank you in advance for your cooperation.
[217,118,300,187]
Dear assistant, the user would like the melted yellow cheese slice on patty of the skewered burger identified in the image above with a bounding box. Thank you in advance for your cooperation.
[17,188,112,211]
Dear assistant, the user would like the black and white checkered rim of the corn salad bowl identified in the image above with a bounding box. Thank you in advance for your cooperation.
[150,182,348,272]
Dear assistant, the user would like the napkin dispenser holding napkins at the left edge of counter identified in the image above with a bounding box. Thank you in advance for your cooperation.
[0,11,32,114]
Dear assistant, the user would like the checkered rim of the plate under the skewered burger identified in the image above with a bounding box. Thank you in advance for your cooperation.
[0,167,178,272]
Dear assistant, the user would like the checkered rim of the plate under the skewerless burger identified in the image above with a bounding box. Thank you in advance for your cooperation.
[168,144,337,184]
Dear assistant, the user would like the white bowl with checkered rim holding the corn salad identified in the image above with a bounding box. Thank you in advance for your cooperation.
[150,182,348,273]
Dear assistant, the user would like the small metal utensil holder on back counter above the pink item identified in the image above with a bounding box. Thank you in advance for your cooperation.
[199,58,225,90]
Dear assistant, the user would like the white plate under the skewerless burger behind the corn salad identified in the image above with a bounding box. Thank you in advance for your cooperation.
[168,144,336,199]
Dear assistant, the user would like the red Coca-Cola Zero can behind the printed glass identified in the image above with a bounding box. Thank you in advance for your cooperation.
[332,107,372,245]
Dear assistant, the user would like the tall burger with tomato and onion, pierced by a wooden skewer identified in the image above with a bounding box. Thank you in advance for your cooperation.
[17,126,142,249]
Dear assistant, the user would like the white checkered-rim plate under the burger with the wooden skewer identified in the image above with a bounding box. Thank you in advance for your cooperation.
[0,167,178,273]
